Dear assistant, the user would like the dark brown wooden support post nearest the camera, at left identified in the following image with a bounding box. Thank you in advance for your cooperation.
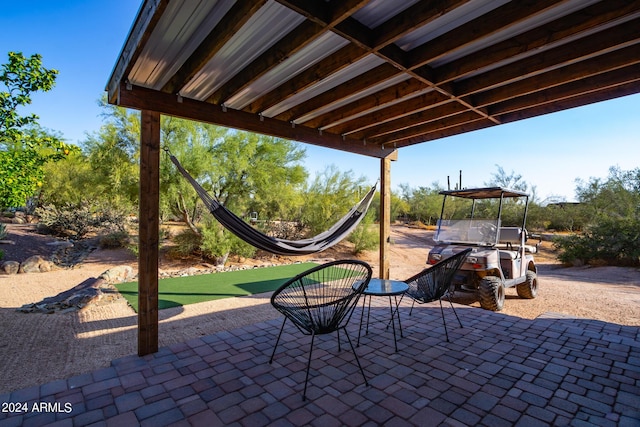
[138,110,160,356]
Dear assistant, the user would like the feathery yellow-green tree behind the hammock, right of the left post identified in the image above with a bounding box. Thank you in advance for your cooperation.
[161,118,307,232]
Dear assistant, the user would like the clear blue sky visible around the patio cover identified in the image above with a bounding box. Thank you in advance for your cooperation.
[0,0,640,201]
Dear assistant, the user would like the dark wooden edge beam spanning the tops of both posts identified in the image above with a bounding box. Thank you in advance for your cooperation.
[117,83,397,160]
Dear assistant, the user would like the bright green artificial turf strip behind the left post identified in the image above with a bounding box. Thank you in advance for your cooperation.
[116,262,317,312]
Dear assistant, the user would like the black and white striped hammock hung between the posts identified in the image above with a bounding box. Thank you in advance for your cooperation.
[169,153,377,255]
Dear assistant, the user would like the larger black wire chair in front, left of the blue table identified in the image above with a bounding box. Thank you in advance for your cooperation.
[269,260,372,400]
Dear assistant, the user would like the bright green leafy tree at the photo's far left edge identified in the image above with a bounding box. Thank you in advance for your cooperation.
[0,52,77,208]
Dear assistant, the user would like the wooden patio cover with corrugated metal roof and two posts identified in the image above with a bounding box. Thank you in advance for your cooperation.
[107,0,640,355]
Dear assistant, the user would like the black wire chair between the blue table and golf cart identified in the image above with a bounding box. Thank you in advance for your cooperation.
[405,248,472,341]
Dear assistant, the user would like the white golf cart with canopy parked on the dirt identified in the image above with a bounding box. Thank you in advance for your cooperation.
[427,187,539,311]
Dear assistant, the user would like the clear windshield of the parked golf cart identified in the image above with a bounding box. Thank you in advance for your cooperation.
[434,219,500,246]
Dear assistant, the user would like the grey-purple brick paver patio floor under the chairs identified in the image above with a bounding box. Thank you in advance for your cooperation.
[0,302,640,427]
